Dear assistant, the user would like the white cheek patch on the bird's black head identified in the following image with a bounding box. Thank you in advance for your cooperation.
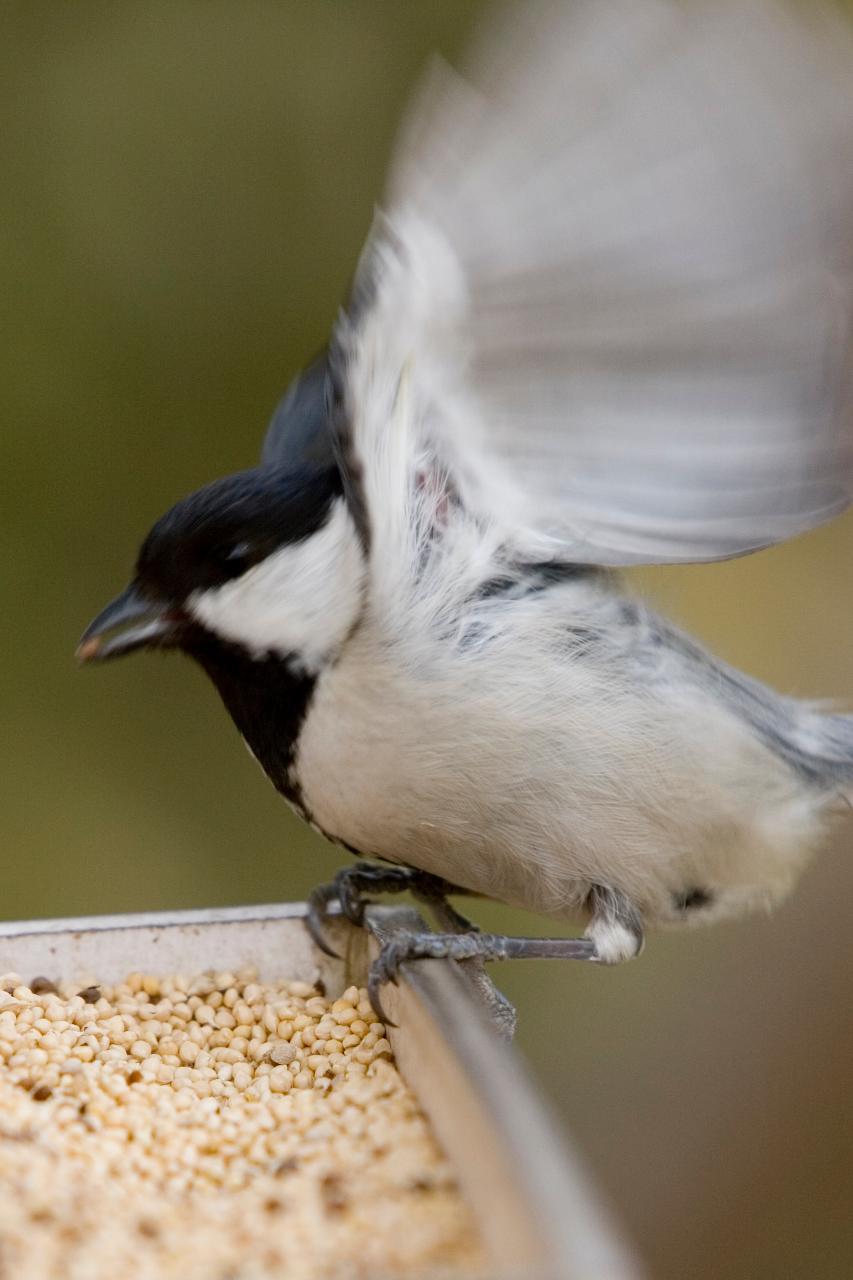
[187,500,365,671]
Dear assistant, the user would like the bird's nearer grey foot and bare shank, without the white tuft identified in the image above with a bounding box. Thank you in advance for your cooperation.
[368,933,601,1027]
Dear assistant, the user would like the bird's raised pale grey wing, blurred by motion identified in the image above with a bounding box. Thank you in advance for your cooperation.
[333,0,853,564]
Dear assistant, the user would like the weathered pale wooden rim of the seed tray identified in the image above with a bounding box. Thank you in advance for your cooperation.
[0,904,640,1280]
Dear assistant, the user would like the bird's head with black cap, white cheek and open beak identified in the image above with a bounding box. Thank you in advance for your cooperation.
[78,465,365,673]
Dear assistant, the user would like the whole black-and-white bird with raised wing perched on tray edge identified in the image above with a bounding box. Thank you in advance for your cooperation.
[78,0,853,1018]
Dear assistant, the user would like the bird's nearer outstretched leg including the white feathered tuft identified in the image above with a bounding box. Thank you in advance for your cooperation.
[368,884,643,1023]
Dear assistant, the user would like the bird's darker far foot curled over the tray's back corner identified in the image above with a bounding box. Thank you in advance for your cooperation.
[305,861,476,956]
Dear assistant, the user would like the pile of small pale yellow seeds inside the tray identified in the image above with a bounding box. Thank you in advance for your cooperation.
[0,970,483,1280]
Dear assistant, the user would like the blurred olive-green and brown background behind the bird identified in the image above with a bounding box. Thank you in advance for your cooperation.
[0,0,853,1280]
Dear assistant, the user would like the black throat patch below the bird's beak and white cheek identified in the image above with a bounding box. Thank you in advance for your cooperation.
[181,627,316,819]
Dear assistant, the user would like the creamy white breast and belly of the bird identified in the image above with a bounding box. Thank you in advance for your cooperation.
[296,588,818,923]
